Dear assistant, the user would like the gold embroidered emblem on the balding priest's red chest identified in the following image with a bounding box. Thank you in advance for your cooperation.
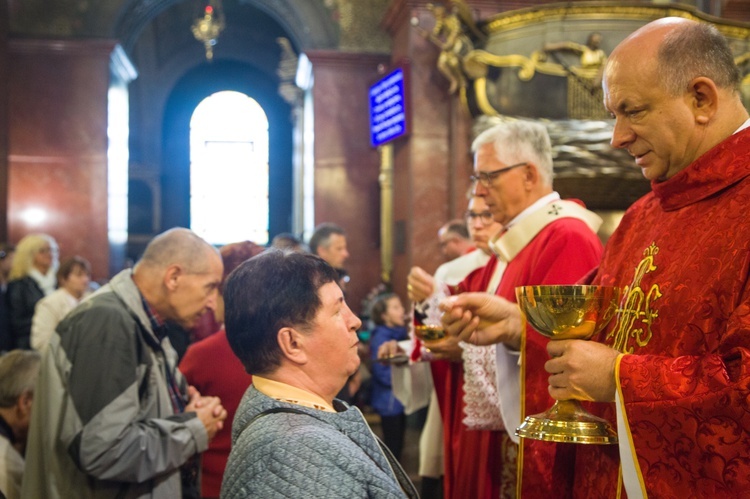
[607,242,662,353]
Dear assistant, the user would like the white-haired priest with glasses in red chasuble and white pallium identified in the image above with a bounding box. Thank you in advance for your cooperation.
[409,121,602,497]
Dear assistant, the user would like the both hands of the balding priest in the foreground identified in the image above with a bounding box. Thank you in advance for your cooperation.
[440,293,620,402]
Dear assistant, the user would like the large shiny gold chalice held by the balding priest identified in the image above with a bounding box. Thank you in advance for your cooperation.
[516,285,622,444]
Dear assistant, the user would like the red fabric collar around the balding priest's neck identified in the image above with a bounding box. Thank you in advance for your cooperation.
[651,127,750,211]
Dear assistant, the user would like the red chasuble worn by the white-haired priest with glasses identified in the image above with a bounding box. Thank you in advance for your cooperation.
[433,208,602,499]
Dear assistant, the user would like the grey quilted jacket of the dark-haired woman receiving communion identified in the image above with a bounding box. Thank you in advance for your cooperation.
[221,386,413,499]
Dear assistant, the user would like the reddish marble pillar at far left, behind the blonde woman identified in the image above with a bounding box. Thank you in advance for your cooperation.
[7,39,114,279]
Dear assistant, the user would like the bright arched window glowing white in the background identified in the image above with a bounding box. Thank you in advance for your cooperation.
[190,91,268,245]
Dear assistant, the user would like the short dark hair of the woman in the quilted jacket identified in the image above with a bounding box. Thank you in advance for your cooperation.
[224,249,338,375]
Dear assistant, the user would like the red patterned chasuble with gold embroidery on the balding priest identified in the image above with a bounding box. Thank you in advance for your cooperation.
[574,129,750,498]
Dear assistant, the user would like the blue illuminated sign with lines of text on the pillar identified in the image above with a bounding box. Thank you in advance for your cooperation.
[370,68,407,147]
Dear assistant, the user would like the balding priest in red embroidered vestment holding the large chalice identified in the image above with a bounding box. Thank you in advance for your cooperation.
[447,18,750,499]
